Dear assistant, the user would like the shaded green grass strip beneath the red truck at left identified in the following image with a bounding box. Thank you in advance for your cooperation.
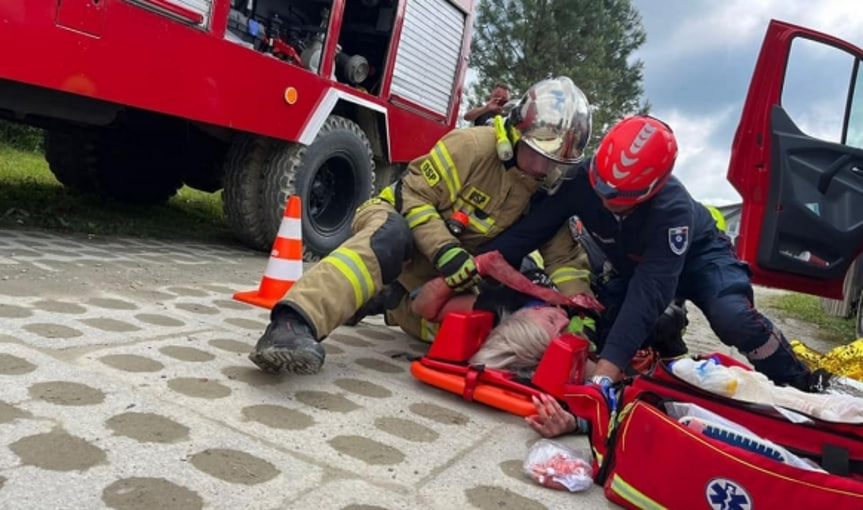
[0,143,236,243]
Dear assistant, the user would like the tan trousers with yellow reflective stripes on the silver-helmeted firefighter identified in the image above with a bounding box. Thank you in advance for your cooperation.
[271,198,438,341]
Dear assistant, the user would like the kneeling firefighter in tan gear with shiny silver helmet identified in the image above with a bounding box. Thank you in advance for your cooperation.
[249,77,591,374]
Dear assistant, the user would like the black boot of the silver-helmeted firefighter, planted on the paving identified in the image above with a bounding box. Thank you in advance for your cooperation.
[249,305,326,374]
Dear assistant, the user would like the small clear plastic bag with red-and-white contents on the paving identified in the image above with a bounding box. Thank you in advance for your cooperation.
[522,439,593,492]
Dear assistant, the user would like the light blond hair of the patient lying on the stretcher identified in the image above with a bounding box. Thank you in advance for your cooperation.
[470,308,551,372]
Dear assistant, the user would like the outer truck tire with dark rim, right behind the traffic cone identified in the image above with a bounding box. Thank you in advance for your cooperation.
[264,115,375,262]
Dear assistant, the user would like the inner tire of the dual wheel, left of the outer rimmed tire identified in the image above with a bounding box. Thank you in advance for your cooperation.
[222,135,274,251]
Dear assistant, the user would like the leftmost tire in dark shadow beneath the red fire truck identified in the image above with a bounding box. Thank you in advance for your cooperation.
[43,131,97,193]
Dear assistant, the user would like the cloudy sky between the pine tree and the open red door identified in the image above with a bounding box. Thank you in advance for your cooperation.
[633,0,863,205]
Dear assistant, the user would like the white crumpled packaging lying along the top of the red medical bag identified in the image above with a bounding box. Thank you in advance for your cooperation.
[670,358,863,423]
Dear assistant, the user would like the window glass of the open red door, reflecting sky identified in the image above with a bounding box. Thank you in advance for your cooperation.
[781,37,863,147]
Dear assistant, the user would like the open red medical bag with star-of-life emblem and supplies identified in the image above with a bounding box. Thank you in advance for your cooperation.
[563,353,863,509]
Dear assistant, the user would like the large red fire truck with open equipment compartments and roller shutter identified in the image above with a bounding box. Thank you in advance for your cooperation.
[0,0,475,260]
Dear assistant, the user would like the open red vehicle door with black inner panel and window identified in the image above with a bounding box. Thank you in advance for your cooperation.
[728,21,863,299]
